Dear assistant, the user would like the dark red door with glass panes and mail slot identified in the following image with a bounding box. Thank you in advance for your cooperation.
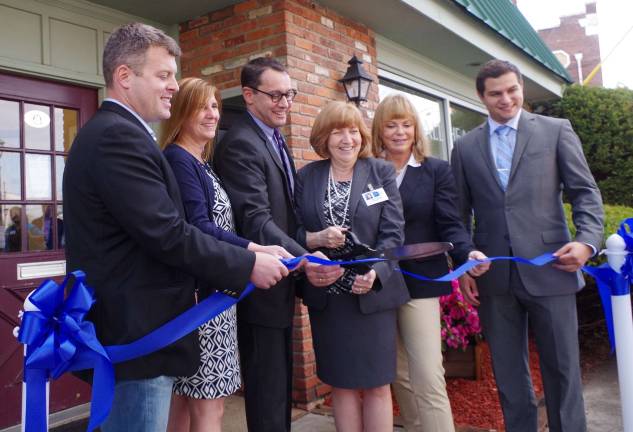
[0,74,97,429]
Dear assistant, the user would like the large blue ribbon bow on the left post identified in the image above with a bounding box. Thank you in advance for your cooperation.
[18,271,114,431]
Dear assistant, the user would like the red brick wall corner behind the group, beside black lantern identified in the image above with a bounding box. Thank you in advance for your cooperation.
[180,0,378,409]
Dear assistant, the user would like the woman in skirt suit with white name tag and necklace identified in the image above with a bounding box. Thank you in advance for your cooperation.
[295,102,409,432]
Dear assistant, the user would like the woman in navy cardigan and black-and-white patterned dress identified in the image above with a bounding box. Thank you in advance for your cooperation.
[160,78,291,432]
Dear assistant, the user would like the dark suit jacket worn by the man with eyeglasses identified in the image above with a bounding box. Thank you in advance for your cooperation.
[213,113,306,328]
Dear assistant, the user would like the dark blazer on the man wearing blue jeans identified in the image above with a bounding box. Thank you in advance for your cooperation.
[63,102,255,379]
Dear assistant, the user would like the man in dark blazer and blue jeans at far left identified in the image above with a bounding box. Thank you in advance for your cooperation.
[63,23,288,432]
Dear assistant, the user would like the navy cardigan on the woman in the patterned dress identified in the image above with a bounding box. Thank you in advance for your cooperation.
[163,144,249,248]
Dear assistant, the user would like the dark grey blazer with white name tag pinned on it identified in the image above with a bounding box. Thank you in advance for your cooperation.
[295,158,409,314]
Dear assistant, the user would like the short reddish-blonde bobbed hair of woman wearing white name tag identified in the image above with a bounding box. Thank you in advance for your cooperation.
[310,101,372,159]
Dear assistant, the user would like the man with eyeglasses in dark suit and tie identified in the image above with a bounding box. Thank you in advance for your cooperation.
[214,58,340,432]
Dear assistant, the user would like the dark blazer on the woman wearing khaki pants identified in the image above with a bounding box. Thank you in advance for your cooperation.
[400,157,474,298]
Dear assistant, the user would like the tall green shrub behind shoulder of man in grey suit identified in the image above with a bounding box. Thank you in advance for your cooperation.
[535,85,633,207]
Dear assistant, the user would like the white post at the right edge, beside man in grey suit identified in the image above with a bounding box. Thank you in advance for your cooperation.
[605,234,633,432]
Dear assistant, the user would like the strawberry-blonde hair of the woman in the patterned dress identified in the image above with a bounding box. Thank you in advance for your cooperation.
[158,78,221,161]
